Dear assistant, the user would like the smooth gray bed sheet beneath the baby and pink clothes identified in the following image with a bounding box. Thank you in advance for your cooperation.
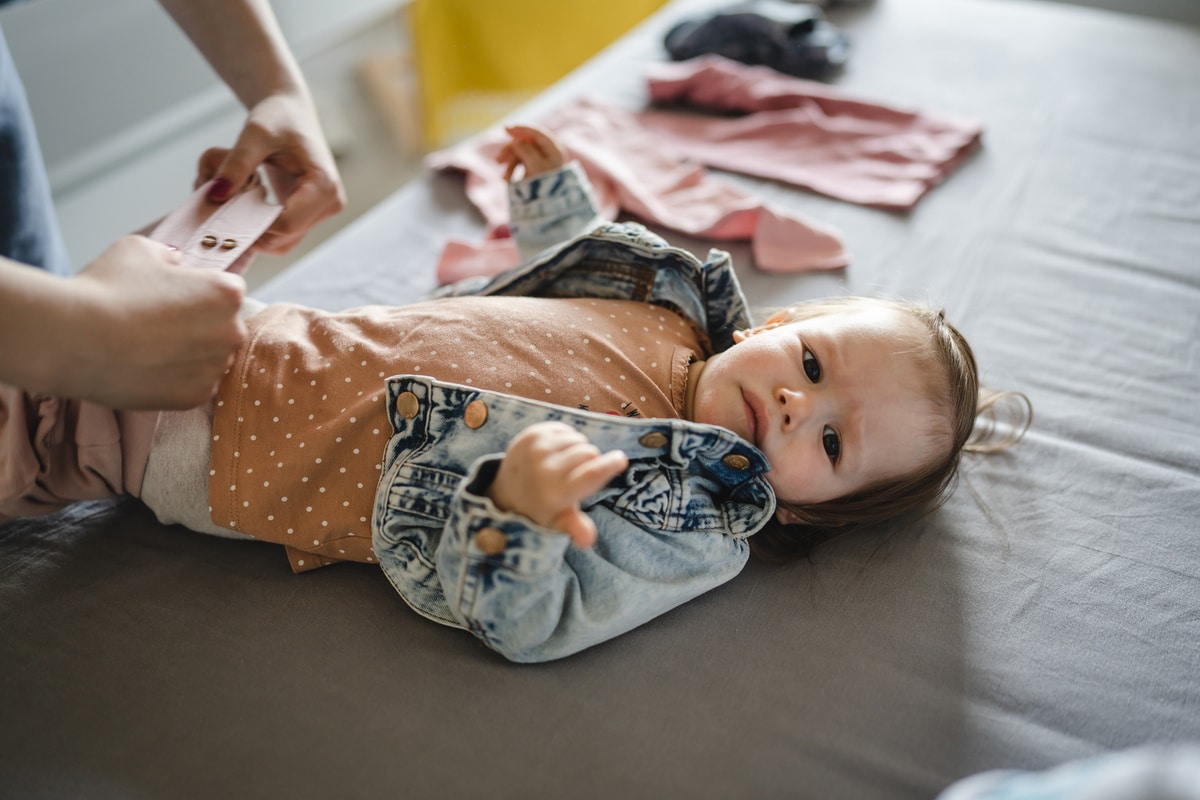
[0,0,1200,799]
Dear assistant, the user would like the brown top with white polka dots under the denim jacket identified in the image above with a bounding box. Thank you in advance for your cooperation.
[209,297,708,571]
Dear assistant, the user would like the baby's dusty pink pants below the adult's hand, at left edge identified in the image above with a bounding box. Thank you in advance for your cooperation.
[0,384,158,522]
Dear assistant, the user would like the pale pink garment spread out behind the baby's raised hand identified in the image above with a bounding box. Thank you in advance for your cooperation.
[427,101,850,283]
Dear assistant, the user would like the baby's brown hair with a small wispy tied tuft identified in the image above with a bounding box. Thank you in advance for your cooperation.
[750,297,1033,561]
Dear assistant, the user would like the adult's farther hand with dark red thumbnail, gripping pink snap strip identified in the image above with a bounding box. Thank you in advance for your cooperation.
[196,92,346,254]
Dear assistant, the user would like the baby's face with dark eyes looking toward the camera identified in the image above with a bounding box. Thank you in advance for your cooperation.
[691,307,949,505]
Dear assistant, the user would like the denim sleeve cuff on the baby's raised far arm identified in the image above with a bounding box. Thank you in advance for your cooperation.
[509,161,605,264]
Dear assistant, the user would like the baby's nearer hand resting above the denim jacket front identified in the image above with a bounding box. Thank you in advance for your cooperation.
[488,422,629,547]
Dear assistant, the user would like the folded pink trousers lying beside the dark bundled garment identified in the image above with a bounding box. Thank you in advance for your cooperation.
[636,56,983,210]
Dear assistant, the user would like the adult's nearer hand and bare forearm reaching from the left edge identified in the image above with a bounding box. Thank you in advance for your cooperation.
[0,235,246,409]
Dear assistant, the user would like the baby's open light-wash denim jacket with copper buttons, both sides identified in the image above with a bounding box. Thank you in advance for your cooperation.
[372,164,775,662]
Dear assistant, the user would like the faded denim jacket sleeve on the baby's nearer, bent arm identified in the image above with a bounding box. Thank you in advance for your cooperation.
[437,456,749,662]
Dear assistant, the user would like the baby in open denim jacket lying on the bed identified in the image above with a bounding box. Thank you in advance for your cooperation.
[0,127,1032,661]
